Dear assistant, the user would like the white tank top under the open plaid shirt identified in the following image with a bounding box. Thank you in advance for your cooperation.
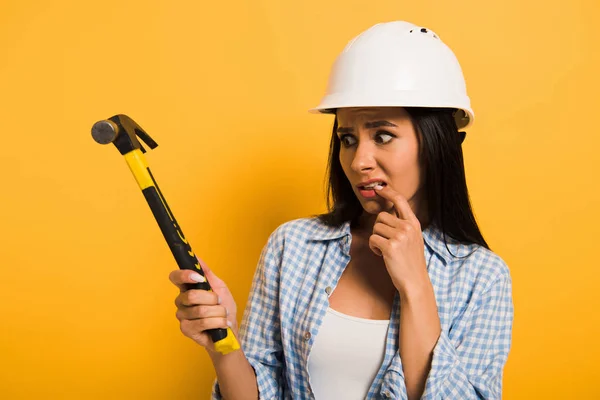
[308,308,389,400]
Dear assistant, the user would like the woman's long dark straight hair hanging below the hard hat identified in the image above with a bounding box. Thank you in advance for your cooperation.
[315,107,489,249]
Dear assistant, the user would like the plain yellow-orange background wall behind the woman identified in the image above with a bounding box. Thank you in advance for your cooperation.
[0,0,600,400]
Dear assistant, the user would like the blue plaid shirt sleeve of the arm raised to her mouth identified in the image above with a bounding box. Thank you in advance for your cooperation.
[421,266,514,400]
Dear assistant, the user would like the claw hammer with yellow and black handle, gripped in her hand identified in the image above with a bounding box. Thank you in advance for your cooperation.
[92,114,240,354]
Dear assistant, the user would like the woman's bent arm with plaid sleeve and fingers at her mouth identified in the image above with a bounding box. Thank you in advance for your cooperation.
[369,186,513,400]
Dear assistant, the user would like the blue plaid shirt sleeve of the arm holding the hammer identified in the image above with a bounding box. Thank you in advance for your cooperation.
[212,229,283,400]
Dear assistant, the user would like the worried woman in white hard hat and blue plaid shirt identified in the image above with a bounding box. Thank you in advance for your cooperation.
[171,21,513,399]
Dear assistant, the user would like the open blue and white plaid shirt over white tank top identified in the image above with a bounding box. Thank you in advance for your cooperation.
[212,217,513,400]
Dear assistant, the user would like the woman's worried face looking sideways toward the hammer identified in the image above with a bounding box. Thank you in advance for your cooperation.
[337,107,422,228]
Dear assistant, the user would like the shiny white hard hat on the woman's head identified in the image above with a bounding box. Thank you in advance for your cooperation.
[309,21,474,129]
